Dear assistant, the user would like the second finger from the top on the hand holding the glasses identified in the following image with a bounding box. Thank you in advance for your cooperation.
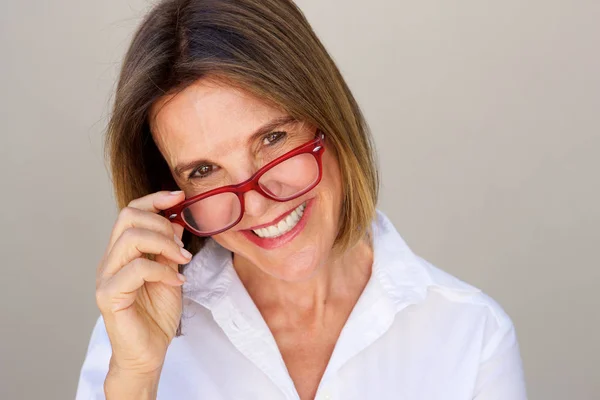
[106,206,180,254]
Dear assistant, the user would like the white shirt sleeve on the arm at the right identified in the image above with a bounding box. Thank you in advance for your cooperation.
[474,315,527,400]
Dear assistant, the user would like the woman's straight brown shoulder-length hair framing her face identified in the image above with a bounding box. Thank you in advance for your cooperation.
[105,0,378,260]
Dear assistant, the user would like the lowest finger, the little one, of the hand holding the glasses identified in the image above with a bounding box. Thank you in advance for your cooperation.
[96,258,185,313]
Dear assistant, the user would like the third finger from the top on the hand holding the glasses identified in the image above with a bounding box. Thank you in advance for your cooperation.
[100,228,192,278]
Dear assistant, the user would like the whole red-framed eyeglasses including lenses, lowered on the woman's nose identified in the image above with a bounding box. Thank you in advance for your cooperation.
[163,129,325,236]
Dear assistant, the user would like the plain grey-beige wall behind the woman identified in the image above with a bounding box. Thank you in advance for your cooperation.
[0,0,600,400]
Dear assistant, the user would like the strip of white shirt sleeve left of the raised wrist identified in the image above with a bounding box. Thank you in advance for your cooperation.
[75,317,112,400]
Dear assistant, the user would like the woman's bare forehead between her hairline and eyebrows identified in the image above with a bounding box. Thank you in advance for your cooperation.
[150,79,285,161]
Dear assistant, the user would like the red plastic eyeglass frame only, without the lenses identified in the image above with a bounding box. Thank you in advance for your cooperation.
[163,128,325,237]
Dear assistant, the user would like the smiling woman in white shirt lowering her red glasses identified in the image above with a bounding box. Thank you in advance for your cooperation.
[77,0,525,400]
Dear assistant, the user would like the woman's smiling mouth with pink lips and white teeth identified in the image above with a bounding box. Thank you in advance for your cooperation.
[240,199,313,249]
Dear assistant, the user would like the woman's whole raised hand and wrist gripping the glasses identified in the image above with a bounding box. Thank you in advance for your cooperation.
[96,191,192,376]
